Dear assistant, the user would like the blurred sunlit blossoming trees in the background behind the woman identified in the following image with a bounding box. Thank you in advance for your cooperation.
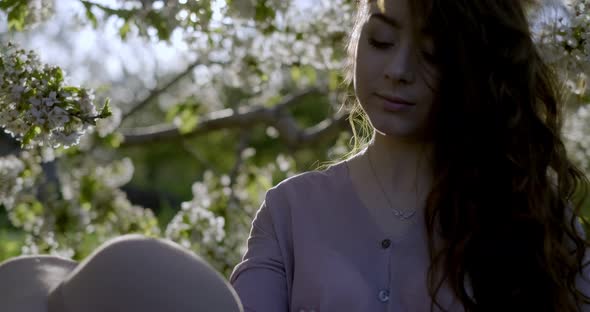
[0,0,590,275]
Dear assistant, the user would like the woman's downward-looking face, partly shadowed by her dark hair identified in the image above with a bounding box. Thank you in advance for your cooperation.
[354,0,439,140]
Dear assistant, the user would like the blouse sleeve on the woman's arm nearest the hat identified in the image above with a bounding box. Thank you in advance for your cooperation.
[230,200,289,312]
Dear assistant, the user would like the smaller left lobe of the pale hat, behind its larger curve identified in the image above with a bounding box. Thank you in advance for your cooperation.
[0,256,77,312]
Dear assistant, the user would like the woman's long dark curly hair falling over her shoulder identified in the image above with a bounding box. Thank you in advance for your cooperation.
[347,0,590,312]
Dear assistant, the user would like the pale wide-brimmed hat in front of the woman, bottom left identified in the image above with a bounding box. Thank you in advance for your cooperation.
[0,235,243,312]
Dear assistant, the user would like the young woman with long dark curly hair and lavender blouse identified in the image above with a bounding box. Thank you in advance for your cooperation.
[230,0,590,312]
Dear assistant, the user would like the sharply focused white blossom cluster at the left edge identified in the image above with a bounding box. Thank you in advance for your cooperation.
[0,43,106,147]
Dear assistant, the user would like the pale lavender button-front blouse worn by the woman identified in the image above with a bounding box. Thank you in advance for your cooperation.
[230,162,590,312]
